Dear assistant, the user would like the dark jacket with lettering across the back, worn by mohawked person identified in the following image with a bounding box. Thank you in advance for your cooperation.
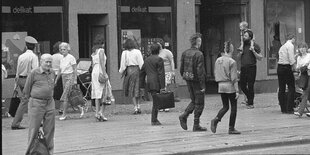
[180,48,206,89]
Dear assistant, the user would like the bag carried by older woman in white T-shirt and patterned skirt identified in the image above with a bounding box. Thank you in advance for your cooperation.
[68,84,85,106]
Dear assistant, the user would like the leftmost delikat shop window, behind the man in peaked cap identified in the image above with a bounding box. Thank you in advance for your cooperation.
[1,0,63,78]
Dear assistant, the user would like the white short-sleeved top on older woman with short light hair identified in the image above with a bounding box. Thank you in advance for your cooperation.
[60,54,76,74]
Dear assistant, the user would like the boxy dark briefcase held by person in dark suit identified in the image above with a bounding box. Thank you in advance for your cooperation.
[153,92,175,110]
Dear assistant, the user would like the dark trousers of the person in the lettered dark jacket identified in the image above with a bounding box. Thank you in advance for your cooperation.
[185,81,205,123]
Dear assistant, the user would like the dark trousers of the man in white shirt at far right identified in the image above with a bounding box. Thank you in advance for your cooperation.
[277,64,295,113]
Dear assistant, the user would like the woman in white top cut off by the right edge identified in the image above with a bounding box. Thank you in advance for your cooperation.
[294,43,310,117]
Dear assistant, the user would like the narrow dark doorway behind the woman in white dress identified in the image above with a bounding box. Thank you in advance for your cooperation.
[78,14,108,58]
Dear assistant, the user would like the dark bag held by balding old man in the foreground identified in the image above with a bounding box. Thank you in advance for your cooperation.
[27,131,50,155]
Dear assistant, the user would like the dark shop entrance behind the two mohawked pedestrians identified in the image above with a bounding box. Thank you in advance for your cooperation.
[200,0,247,81]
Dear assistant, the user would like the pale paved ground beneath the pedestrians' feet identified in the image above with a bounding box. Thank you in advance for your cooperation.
[2,93,310,155]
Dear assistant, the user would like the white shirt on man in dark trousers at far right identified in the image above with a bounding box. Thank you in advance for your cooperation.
[278,40,295,65]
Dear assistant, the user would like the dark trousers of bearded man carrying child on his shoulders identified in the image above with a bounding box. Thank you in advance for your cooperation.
[240,66,256,105]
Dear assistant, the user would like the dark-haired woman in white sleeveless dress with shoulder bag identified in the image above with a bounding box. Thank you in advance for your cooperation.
[91,34,111,121]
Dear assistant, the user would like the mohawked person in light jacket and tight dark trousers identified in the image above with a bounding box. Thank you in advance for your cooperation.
[211,41,240,134]
